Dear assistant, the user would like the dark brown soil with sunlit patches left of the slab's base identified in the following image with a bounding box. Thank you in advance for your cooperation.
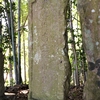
[5,84,29,100]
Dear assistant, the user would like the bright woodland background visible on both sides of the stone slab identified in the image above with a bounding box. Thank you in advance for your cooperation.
[0,0,87,100]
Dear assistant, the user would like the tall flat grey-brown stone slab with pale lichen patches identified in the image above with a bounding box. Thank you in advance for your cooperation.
[29,0,70,100]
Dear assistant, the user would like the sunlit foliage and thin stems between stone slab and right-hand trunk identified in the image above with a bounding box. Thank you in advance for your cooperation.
[66,0,87,85]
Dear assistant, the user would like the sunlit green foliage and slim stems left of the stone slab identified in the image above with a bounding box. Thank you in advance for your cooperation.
[0,0,28,85]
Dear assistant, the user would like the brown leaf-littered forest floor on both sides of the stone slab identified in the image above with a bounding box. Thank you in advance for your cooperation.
[5,84,83,100]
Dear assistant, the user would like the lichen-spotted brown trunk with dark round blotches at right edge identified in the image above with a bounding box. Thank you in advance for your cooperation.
[78,0,100,100]
